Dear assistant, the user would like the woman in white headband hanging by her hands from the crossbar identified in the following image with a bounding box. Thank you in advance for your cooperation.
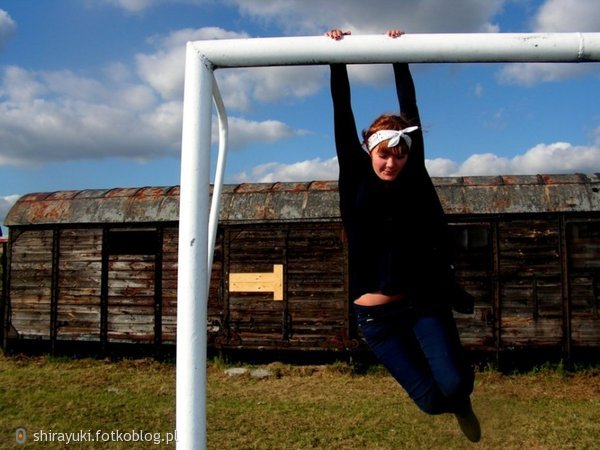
[326,30,481,442]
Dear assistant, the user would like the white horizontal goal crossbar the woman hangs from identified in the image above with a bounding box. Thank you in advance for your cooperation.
[193,33,600,68]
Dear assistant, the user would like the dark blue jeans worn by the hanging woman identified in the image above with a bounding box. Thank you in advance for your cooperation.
[353,301,474,414]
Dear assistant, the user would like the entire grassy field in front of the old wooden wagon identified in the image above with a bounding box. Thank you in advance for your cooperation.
[0,355,600,450]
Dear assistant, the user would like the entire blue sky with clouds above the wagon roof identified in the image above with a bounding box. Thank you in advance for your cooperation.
[0,0,600,232]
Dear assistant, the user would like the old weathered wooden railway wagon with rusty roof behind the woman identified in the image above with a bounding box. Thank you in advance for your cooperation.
[0,175,600,360]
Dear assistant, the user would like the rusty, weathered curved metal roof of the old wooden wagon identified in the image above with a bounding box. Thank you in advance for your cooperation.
[5,174,600,227]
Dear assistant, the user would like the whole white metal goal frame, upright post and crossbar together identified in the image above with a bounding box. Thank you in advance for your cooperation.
[176,33,600,449]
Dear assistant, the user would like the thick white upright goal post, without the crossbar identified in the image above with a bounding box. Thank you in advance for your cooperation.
[176,44,213,449]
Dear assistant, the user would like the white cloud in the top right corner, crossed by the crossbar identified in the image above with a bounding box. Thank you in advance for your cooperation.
[499,0,600,86]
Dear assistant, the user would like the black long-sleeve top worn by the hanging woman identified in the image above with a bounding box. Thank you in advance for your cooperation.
[331,63,450,306]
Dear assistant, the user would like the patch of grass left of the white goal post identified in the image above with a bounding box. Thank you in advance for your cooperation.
[0,356,175,449]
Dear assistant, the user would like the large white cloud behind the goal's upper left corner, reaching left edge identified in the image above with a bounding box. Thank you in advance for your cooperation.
[0,27,314,165]
